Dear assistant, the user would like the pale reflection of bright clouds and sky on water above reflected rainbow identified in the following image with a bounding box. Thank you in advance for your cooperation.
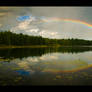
[7,52,92,72]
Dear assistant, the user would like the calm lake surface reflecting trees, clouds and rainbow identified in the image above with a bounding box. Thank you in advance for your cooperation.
[0,47,92,86]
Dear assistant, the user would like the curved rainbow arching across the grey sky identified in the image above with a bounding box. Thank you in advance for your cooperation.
[43,18,92,28]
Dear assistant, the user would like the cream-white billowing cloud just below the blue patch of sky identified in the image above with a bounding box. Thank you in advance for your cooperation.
[11,16,39,33]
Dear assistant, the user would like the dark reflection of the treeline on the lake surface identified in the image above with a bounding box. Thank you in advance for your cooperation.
[0,47,92,58]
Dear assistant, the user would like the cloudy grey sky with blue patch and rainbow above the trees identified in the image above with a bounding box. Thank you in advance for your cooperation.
[0,7,92,40]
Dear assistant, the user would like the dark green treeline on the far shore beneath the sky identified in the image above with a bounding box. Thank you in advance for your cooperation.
[0,31,92,46]
